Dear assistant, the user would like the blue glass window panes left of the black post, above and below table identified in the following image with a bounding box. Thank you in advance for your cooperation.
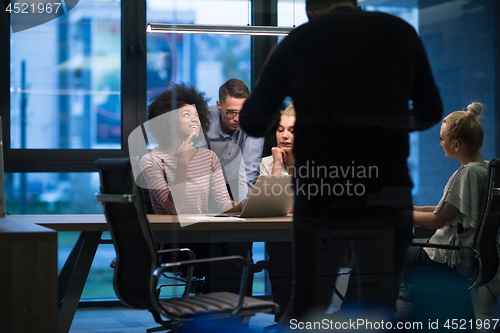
[5,0,122,298]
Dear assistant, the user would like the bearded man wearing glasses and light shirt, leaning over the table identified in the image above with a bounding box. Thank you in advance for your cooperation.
[207,79,264,203]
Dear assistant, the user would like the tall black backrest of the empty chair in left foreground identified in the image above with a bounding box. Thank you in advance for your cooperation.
[95,158,159,310]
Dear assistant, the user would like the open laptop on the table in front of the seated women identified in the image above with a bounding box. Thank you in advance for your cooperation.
[216,175,294,217]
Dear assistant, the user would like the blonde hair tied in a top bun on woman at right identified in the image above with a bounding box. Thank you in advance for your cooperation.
[443,102,484,152]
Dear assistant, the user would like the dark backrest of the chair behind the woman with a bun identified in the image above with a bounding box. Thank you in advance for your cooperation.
[471,158,500,288]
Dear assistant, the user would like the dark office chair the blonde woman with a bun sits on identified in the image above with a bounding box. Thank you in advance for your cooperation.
[402,158,500,322]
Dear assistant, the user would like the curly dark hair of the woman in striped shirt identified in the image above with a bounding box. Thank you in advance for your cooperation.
[147,82,211,146]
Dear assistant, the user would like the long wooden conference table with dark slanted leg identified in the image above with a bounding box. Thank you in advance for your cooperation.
[16,214,293,333]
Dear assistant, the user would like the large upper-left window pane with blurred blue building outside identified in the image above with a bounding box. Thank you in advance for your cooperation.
[10,0,121,149]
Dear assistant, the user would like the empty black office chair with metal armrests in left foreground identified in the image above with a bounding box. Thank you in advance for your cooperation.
[96,158,279,332]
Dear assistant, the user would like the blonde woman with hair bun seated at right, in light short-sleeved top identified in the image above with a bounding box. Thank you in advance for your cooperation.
[408,103,488,276]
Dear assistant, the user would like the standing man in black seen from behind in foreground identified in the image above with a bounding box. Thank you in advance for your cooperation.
[240,0,442,320]
